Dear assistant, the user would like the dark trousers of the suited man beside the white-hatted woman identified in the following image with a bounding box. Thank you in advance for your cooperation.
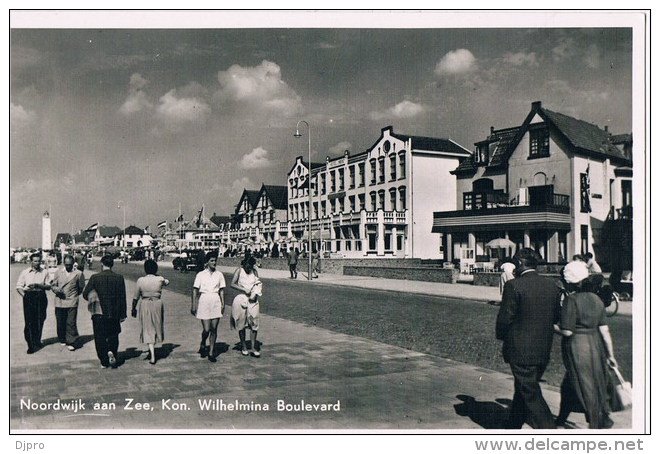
[506,364,556,429]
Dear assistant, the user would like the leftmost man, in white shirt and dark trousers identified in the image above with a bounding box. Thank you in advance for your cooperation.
[16,252,50,355]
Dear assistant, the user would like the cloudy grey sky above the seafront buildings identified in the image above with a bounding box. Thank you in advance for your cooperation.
[9,12,633,247]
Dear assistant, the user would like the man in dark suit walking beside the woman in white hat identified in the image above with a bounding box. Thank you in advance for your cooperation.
[495,248,560,429]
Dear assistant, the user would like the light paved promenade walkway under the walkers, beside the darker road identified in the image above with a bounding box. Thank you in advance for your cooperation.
[10,267,631,433]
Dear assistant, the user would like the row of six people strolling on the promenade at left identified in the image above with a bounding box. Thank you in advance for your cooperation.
[16,253,263,368]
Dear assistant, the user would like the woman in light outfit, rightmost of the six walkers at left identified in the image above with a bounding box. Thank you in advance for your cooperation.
[230,257,263,357]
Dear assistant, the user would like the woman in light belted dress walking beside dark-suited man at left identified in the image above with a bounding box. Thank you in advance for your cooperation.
[131,259,170,364]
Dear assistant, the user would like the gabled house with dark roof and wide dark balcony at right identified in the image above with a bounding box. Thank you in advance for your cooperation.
[432,102,632,268]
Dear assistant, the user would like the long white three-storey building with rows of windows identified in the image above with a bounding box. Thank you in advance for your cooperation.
[287,126,470,259]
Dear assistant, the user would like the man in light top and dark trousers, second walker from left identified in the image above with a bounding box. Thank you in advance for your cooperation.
[51,255,85,351]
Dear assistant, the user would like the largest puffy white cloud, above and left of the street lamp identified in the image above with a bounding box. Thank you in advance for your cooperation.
[216,60,302,117]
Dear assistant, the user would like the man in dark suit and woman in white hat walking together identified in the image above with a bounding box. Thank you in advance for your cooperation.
[496,248,617,429]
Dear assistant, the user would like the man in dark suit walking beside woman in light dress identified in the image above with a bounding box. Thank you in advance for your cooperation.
[83,255,126,368]
